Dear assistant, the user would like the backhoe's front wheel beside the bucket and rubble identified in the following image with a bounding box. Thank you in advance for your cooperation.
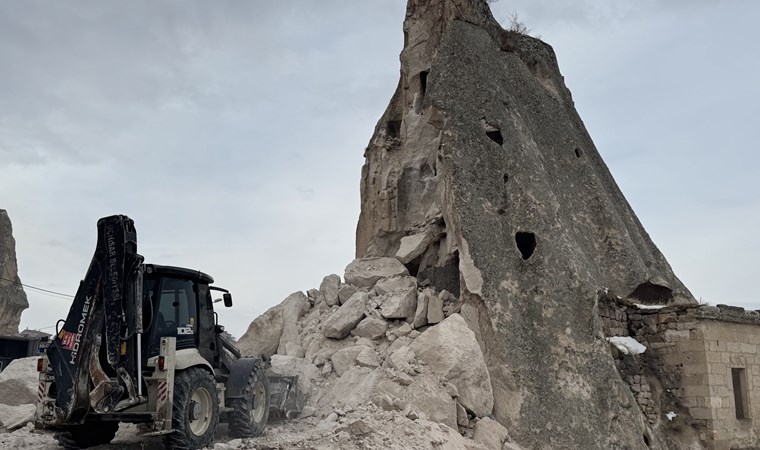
[229,370,269,437]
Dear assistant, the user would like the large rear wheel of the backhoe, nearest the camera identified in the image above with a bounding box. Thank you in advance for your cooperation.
[166,367,219,450]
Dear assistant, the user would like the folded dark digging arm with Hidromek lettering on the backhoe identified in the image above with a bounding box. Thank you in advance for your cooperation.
[47,215,143,424]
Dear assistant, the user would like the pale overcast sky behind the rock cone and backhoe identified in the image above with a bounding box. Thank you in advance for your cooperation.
[0,0,760,336]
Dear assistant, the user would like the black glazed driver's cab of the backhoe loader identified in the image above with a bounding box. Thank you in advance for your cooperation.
[143,264,219,366]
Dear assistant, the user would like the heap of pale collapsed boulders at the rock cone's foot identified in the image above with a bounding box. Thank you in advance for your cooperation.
[237,257,517,448]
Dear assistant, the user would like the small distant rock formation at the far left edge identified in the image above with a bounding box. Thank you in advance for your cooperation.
[0,209,29,334]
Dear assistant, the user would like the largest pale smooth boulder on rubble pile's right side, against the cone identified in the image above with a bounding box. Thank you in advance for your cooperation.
[410,314,493,417]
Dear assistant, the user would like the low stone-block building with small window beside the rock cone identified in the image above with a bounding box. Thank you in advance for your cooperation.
[599,299,760,450]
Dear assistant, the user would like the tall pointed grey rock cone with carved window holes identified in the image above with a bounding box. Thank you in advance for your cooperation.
[356,0,694,449]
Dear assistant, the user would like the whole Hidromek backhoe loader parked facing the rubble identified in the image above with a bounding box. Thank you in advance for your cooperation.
[35,215,304,449]
